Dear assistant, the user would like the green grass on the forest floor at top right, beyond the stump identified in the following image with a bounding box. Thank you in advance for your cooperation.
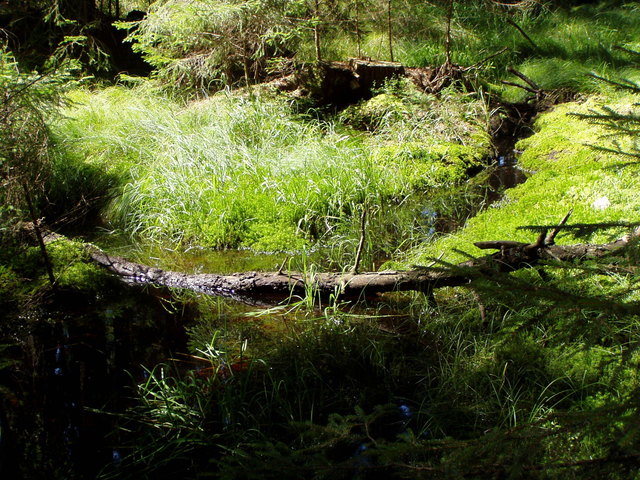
[388,2,640,100]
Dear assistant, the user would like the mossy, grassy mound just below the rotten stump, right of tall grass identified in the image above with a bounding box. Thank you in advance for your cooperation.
[340,79,491,198]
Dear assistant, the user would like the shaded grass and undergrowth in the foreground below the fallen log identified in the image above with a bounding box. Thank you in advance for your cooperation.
[103,262,640,479]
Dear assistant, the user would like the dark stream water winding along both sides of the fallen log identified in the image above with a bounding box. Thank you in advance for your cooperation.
[0,103,526,479]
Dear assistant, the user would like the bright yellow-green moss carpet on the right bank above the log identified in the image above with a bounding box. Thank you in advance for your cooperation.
[408,96,640,264]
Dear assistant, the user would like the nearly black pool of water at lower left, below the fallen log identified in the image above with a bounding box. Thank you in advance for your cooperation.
[0,289,186,479]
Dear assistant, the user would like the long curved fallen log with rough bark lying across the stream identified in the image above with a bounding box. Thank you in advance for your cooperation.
[89,229,640,300]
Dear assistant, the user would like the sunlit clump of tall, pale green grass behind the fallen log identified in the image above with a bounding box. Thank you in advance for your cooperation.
[53,88,372,249]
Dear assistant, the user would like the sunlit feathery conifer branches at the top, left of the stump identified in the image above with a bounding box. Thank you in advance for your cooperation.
[117,0,296,91]
